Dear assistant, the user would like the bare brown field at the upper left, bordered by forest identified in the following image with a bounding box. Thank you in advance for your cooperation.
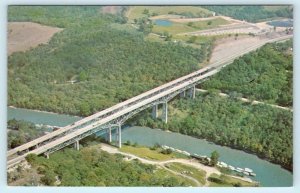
[7,22,62,55]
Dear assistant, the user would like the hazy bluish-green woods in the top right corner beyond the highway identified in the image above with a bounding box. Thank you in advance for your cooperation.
[201,5,293,22]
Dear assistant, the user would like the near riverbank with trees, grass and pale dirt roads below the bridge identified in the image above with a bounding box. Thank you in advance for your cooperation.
[8,128,258,187]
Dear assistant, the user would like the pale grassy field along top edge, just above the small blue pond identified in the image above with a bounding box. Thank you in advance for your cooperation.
[127,6,211,20]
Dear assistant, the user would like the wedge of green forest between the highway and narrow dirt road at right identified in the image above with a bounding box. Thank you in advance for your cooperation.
[200,40,293,107]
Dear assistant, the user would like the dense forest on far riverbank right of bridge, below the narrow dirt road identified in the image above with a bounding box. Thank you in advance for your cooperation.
[132,93,293,170]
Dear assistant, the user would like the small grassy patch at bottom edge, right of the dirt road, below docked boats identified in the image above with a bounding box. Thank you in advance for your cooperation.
[209,174,255,187]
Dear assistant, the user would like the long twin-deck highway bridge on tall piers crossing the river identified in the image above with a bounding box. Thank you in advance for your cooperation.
[7,35,292,168]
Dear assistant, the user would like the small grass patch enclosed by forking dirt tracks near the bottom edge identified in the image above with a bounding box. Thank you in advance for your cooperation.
[167,163,206,185]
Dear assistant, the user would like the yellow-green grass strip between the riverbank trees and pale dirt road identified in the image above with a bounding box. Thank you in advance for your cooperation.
[120,145,187,161]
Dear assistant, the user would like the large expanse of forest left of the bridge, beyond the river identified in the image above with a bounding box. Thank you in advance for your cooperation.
[8,6,207,116]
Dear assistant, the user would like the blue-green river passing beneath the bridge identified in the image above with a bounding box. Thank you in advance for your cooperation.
[8,107,293,187]
